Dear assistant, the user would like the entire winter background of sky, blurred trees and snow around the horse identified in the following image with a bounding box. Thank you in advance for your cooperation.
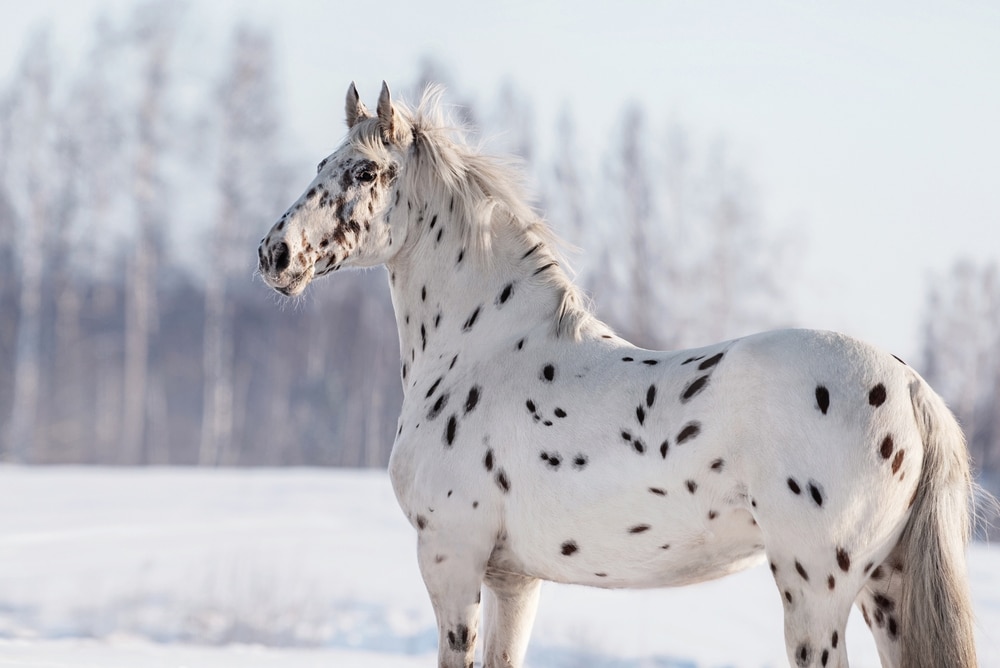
[0,0,1000,668]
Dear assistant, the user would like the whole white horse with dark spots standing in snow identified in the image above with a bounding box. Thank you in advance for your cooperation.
[259,85,976,668]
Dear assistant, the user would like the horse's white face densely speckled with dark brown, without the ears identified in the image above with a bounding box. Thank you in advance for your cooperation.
[257,138,398,295]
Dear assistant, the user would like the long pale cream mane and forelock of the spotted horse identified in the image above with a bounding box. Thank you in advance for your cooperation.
[360,86,610,340]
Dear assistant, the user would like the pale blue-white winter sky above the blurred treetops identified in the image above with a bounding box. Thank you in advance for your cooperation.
[0,0,1000,361]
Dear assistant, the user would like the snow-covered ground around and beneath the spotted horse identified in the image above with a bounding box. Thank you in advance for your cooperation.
[0,467,1000,668]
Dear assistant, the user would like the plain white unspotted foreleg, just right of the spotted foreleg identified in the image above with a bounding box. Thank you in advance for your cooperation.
[483,571,542,668]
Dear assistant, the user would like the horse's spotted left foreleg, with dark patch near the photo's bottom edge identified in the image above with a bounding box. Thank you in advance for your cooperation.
[417,532,489,668]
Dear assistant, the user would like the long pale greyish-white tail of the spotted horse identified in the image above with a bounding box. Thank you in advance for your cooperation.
[900,379,977,668]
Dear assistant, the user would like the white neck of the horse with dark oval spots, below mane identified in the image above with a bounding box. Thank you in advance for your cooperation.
[387,185,599,393]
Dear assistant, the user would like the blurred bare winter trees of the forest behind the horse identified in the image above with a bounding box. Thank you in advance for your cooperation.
[0,2,1000,489]
